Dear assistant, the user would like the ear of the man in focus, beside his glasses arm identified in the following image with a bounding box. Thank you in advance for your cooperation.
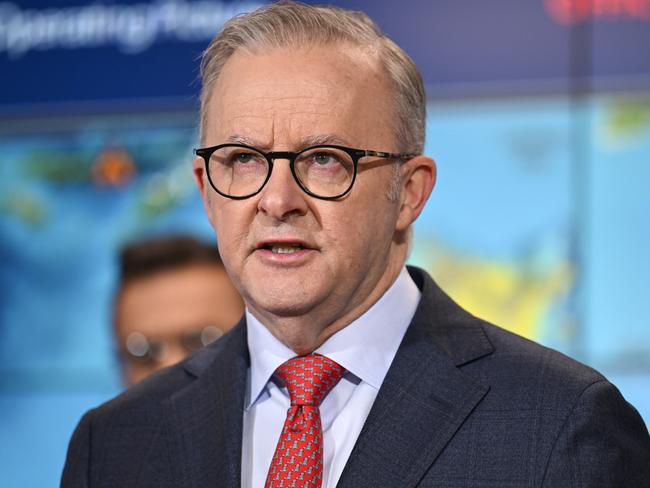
[396,156,437,231]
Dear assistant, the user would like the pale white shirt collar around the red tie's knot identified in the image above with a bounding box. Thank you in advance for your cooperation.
[245,268,420,409]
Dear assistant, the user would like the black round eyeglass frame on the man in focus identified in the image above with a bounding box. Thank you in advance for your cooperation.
[194,143,419,200]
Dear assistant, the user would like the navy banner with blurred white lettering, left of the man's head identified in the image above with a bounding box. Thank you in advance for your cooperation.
[0,0,262,112]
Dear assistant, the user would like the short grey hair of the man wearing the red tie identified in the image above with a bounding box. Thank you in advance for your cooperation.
[201,1,426,153]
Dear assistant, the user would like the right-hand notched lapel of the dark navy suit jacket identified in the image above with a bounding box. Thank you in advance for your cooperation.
[337,269,492,488]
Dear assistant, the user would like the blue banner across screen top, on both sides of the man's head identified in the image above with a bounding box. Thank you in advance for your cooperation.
[0,0,650,114]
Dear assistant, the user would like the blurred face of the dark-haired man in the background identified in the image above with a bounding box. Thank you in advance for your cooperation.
[115,264,244,384]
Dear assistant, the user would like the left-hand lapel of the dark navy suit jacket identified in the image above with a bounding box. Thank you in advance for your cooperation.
[164,319,249,488]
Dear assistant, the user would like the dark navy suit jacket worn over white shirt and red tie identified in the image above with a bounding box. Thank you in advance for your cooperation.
[62,268,650,488]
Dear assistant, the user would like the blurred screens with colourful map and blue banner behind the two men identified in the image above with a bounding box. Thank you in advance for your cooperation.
[0,0,650,488]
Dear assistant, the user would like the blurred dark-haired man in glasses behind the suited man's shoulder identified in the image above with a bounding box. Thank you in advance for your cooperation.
[113,236,244,385]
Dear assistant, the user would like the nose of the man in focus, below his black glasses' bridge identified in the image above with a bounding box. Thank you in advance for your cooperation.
[258,158,307,220]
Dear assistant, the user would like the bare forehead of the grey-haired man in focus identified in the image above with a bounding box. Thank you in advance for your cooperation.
[204,44,393,149]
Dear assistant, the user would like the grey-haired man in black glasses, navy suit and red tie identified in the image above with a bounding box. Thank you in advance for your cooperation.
[63,2,650,488]
